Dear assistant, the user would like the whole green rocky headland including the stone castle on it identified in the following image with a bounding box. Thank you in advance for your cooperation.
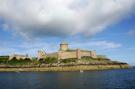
[0,42,131,71]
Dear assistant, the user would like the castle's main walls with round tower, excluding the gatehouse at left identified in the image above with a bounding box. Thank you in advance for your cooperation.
[58,42,97,59]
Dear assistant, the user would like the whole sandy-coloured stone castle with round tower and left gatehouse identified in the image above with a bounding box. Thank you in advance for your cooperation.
[37,42,97,59]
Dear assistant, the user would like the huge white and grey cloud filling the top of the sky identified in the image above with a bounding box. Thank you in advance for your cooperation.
[0,0,135,38]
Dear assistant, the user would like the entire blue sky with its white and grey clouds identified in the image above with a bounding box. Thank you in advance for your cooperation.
[0,0,135,65]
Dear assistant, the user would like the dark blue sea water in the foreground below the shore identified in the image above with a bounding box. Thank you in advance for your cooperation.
[0,68,135,89]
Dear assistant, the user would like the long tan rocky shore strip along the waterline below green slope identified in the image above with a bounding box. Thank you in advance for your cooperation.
[0,64,131,72]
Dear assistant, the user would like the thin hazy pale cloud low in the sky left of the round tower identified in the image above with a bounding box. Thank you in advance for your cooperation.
[0,41,59,56]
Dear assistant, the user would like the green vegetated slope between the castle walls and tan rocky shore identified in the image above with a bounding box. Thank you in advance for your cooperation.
[0,57,126,67]
